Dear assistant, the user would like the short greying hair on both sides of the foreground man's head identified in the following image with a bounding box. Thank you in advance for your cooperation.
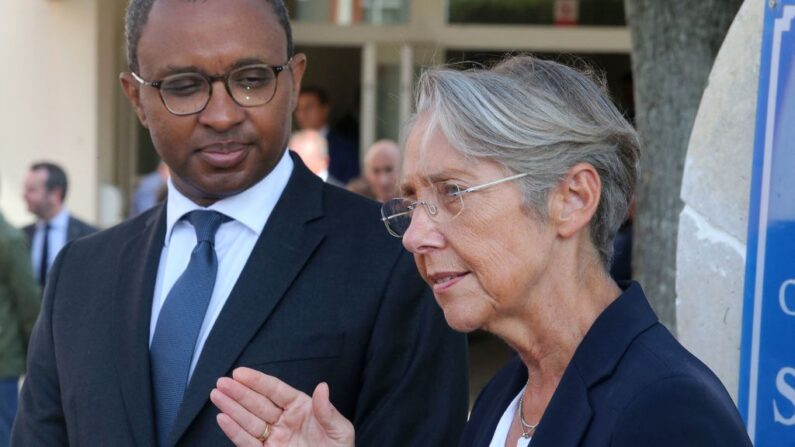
[124,0,295,72]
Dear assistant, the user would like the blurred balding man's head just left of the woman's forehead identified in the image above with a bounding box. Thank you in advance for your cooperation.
[364,140,400,202]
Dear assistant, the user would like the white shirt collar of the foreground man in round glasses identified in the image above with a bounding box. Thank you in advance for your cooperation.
[165,151,294,246]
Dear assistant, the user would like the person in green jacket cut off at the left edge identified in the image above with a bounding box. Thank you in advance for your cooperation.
[0,174,41,446]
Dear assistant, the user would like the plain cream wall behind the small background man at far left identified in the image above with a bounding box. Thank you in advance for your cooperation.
[0,0,101,224]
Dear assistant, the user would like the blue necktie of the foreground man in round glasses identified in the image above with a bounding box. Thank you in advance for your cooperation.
[149,211,230,446]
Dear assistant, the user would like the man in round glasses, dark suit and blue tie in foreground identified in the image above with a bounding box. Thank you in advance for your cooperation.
[12,0,467,447]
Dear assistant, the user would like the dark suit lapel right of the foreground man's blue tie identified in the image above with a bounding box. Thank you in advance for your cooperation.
[169,157,325,445]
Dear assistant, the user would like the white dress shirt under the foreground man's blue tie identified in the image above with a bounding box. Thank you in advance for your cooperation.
[149,151,293,375]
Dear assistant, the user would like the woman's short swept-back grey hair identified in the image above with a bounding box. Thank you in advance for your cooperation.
[404,56,640,269]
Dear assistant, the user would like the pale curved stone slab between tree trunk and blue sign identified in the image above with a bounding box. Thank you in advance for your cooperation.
[676,0,766,401]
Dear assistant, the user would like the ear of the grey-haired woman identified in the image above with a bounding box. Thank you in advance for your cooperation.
[550,163,602,238]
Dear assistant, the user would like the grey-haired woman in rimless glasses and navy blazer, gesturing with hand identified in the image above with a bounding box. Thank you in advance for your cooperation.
[213,56,751,447]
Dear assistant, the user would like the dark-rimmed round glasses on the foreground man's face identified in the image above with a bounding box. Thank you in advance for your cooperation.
[130,59,292,116]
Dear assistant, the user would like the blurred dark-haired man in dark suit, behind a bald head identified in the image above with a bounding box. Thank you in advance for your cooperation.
[295,86,359,183]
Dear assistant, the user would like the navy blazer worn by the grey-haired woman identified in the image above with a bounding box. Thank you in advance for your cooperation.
[460,282,751,447]
